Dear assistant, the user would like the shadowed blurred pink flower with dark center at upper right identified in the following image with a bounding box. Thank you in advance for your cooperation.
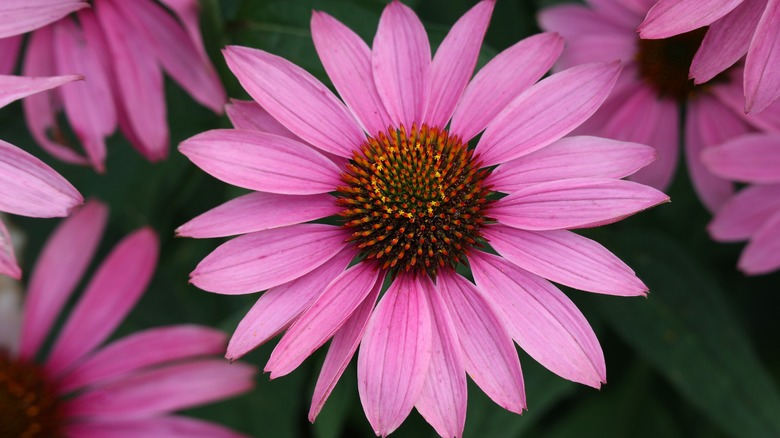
[539,0,780,211]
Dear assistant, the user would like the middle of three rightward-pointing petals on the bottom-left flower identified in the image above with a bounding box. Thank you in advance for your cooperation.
[63,359,256,422]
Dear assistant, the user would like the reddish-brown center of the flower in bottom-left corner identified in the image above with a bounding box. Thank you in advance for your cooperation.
[0,348,62,438]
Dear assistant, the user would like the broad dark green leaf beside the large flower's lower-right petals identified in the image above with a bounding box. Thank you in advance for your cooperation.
[600,230,780,437]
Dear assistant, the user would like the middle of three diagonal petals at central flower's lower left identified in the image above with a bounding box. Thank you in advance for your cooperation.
[265,263,379,379]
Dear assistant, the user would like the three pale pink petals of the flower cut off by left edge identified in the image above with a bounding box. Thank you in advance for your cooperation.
[0,75,84,279]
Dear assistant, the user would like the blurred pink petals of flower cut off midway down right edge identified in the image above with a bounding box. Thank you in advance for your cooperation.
[702,134,780,275]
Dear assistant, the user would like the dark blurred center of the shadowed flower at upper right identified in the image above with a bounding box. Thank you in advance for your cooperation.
[636,27,725,101]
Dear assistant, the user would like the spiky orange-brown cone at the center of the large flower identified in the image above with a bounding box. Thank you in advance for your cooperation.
[337,125,491,278]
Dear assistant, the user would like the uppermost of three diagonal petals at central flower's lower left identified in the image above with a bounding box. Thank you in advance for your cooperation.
[225,248,355,360]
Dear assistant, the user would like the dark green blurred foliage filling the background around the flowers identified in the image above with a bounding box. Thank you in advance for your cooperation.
[0,0,780,438]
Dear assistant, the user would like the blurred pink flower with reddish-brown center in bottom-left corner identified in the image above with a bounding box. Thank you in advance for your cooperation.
[0,202,255,437]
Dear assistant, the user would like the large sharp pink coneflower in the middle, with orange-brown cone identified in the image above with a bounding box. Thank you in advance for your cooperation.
[178,1,667,436]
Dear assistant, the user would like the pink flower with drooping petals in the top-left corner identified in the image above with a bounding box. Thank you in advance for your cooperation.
[0,0,226,171]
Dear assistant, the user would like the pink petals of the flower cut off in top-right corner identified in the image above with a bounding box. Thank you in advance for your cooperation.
[638,0,780,112]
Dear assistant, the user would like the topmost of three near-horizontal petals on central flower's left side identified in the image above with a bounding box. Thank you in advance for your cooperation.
[179,129,342,195]
